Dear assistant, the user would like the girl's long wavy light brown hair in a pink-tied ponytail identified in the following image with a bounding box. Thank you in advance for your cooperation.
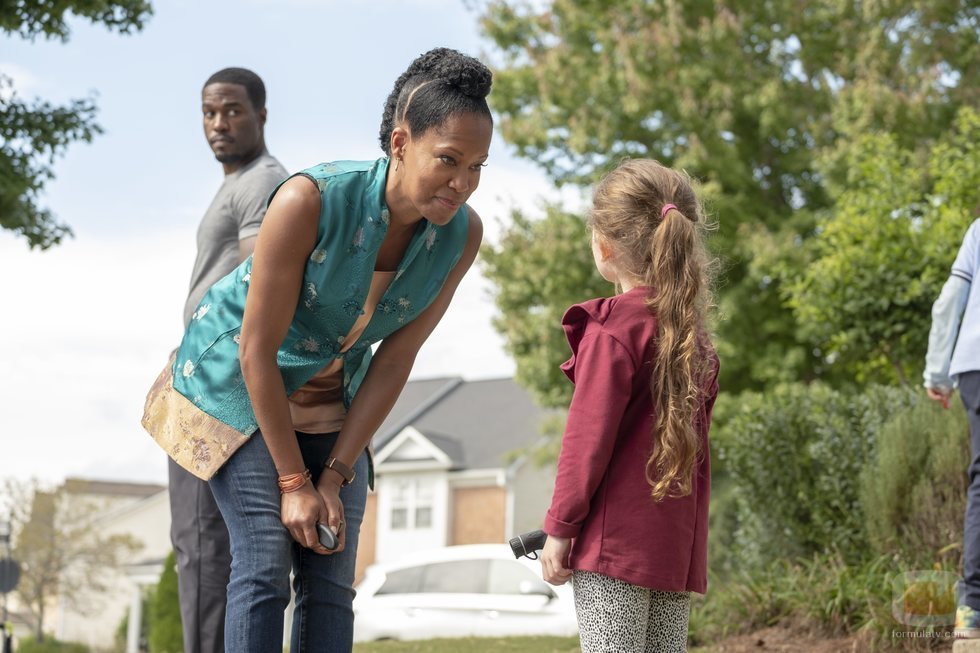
[589,159,715,501]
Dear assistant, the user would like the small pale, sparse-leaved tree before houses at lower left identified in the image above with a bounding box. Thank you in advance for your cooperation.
[2,479,140,642]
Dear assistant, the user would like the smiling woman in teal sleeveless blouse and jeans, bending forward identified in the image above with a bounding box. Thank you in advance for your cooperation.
[144,48,493,652]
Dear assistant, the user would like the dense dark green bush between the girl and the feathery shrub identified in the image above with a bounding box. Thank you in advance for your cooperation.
[715,384,918,569]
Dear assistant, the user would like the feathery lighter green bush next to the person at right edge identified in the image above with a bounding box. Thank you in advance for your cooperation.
[861,395,970,569]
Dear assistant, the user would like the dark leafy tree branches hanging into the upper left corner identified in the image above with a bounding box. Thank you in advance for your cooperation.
[0,0,151,249]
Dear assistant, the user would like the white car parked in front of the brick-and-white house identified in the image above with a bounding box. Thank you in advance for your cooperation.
[354,544,578,642]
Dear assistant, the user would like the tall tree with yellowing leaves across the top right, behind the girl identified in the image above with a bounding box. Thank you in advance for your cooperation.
[482,0,980,390]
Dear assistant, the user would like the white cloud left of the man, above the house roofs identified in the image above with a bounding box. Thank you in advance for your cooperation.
[0,231,193,481]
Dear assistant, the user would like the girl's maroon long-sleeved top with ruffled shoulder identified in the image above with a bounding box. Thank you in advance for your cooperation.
[545,286,718,593]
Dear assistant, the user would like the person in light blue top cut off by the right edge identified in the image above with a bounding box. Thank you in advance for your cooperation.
[923,220,980,638]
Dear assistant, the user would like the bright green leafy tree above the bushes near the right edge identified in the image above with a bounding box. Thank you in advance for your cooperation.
[786,108,980,383]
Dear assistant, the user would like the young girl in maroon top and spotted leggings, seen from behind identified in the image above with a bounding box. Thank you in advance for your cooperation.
[541,159,718,653]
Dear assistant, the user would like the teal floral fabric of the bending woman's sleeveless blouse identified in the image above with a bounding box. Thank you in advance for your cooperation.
[173,158,468,436]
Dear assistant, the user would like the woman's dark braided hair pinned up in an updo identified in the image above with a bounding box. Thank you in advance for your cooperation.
[379,48,493,156]
